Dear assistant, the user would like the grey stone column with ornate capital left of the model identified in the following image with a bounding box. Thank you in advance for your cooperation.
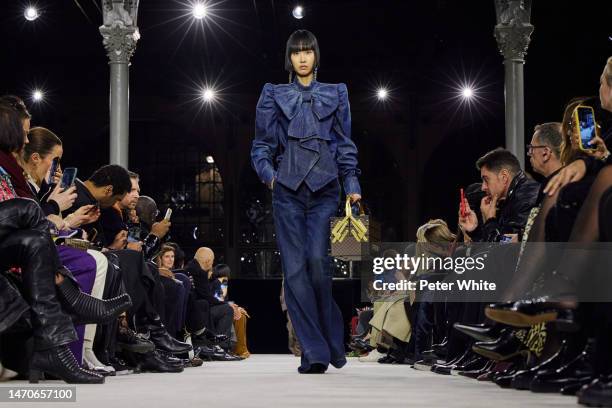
[100,0,140,168]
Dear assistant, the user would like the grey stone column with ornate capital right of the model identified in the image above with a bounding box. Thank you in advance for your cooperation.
[495,0,533,169]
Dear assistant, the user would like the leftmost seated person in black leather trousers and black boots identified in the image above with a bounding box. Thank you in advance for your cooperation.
[0,97,129,383]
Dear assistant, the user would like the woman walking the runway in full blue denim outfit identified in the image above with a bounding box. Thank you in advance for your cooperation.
[251,30,361,374]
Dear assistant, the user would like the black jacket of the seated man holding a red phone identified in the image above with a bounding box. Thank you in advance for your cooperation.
[472,171,540,242]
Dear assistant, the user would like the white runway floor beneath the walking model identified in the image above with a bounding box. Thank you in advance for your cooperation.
[0,355,579,408]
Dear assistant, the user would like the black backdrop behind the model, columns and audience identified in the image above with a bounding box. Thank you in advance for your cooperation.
[0,0,612,352]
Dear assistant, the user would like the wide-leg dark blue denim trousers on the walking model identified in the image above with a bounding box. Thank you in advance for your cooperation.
[272,180,346,370]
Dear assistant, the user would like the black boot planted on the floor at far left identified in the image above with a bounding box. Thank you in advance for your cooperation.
[29,346,104,384]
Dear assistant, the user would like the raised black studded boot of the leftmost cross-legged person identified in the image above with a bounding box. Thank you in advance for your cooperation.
[57,279,132,324]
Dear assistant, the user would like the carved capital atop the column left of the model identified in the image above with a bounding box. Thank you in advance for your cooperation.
[100,0,140,64]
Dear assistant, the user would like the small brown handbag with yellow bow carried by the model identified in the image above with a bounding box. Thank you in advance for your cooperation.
[330,196,380,261]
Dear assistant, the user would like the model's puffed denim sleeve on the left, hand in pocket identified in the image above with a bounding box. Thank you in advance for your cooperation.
[251,84,278,184]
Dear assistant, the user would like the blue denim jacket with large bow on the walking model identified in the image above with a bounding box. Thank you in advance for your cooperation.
[251,81,361,194]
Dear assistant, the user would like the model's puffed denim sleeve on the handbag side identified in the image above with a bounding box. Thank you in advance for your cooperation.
[334,84,361,194]
